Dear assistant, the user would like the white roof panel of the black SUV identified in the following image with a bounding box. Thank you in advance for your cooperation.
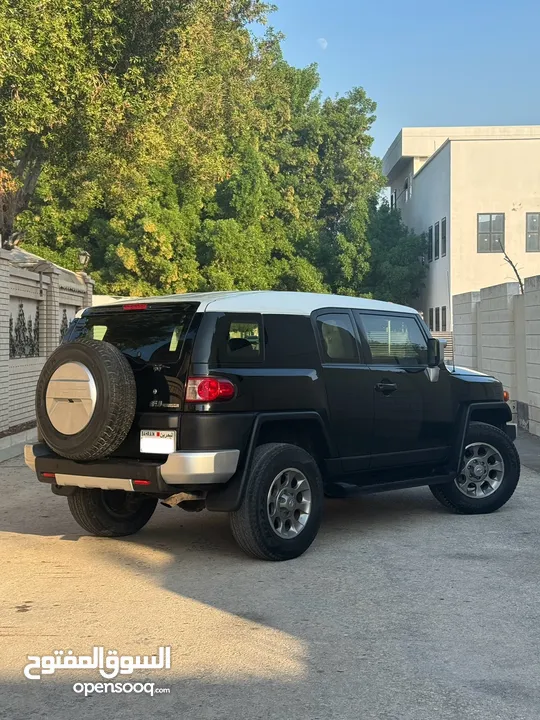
[99,290,417,315]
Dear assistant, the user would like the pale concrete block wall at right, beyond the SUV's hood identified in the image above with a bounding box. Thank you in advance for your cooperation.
[453,276,540,436]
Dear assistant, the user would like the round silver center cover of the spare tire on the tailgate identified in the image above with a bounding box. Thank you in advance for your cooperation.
[45,362,97,435]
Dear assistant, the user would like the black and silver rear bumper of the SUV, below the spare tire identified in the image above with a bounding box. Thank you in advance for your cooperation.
[24,444,240,494]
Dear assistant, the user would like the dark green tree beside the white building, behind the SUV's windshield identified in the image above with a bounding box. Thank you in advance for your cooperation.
[362,201,428,305]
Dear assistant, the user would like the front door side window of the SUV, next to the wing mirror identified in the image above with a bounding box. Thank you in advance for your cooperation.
[360,314,427,367]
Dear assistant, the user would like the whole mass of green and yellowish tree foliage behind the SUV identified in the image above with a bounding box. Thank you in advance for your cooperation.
[0,0,421,298]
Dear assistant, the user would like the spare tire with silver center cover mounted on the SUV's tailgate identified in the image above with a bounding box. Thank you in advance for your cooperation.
[36,340,137,460]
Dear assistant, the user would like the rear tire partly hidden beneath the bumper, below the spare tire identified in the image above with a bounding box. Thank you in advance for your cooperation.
[68,488,157,537]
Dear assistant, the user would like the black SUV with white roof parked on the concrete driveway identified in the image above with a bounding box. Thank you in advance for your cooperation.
[25,292,520,560]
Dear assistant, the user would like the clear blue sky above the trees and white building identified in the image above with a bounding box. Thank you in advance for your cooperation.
[270,0,540,156]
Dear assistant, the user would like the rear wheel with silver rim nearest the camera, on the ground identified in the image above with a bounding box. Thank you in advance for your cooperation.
[230,443,324,561]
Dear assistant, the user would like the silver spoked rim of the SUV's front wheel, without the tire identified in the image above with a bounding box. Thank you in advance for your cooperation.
[455,442,504,498]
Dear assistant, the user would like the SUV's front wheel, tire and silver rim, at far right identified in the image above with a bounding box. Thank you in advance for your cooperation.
[430,422,520,515]
